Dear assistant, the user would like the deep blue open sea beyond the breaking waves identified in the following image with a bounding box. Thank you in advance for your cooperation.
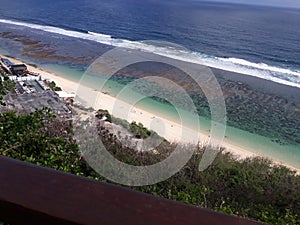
[0,0,300,87]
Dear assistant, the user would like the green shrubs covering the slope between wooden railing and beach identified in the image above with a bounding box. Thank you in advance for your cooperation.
[0,80,300,225]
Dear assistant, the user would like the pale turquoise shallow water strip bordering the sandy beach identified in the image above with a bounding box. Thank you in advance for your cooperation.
[10,61,300,168]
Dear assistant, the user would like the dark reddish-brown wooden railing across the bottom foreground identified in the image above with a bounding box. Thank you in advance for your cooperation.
[0,157,259,225]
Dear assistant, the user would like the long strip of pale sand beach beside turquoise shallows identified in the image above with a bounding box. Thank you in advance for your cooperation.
[0,55,300,173]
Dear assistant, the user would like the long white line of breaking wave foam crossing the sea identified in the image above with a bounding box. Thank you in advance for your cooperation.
[0,19,300,88]
